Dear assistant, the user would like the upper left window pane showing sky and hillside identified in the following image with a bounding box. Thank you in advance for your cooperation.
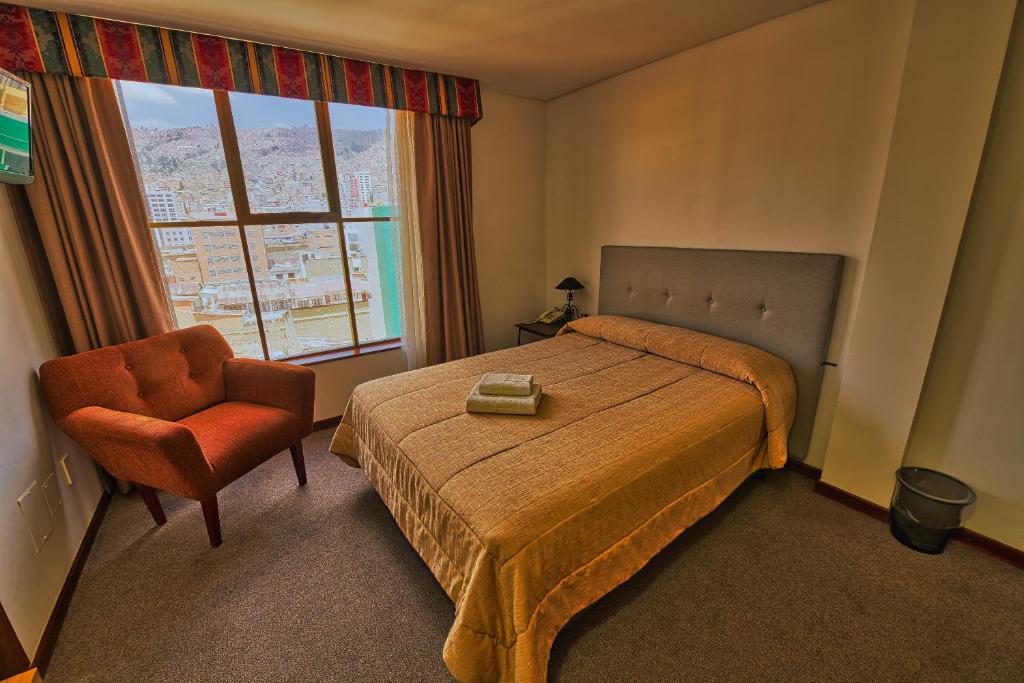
[118,81,234,222]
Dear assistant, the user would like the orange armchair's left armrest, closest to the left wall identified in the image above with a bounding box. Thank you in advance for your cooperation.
[59,405,220,500]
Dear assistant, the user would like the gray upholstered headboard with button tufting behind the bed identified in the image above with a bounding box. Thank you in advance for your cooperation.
[598,246,843,460]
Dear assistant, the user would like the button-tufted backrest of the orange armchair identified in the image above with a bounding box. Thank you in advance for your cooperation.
[39,325,234,423]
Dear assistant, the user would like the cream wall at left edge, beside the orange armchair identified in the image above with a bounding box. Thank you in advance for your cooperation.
[0,187,101,657]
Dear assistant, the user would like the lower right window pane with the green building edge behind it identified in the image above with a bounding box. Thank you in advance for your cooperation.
[345,220,401,344]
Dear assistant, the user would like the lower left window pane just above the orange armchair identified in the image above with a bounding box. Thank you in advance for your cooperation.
[153,226,267,358]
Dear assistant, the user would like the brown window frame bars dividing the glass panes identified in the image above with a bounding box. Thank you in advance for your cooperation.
[118,83,401,362]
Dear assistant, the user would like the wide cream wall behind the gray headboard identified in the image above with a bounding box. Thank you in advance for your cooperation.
[548,0,913,465]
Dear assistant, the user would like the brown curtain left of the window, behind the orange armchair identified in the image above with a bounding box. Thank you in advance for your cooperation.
[26,74,172,351]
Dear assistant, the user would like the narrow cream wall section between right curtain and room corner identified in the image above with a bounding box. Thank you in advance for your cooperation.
[473,89,556,351]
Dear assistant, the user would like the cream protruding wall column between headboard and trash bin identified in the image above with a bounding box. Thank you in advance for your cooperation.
[821,0,1016,505]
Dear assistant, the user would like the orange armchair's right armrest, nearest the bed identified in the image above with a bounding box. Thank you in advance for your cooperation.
[224,358,316,436]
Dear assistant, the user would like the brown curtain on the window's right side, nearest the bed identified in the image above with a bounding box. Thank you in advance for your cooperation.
[395,112,483,368]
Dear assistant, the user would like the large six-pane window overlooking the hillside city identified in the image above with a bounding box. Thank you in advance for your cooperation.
[118,81,401,359]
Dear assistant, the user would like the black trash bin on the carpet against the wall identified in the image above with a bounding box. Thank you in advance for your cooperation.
[889,467,975,555]
